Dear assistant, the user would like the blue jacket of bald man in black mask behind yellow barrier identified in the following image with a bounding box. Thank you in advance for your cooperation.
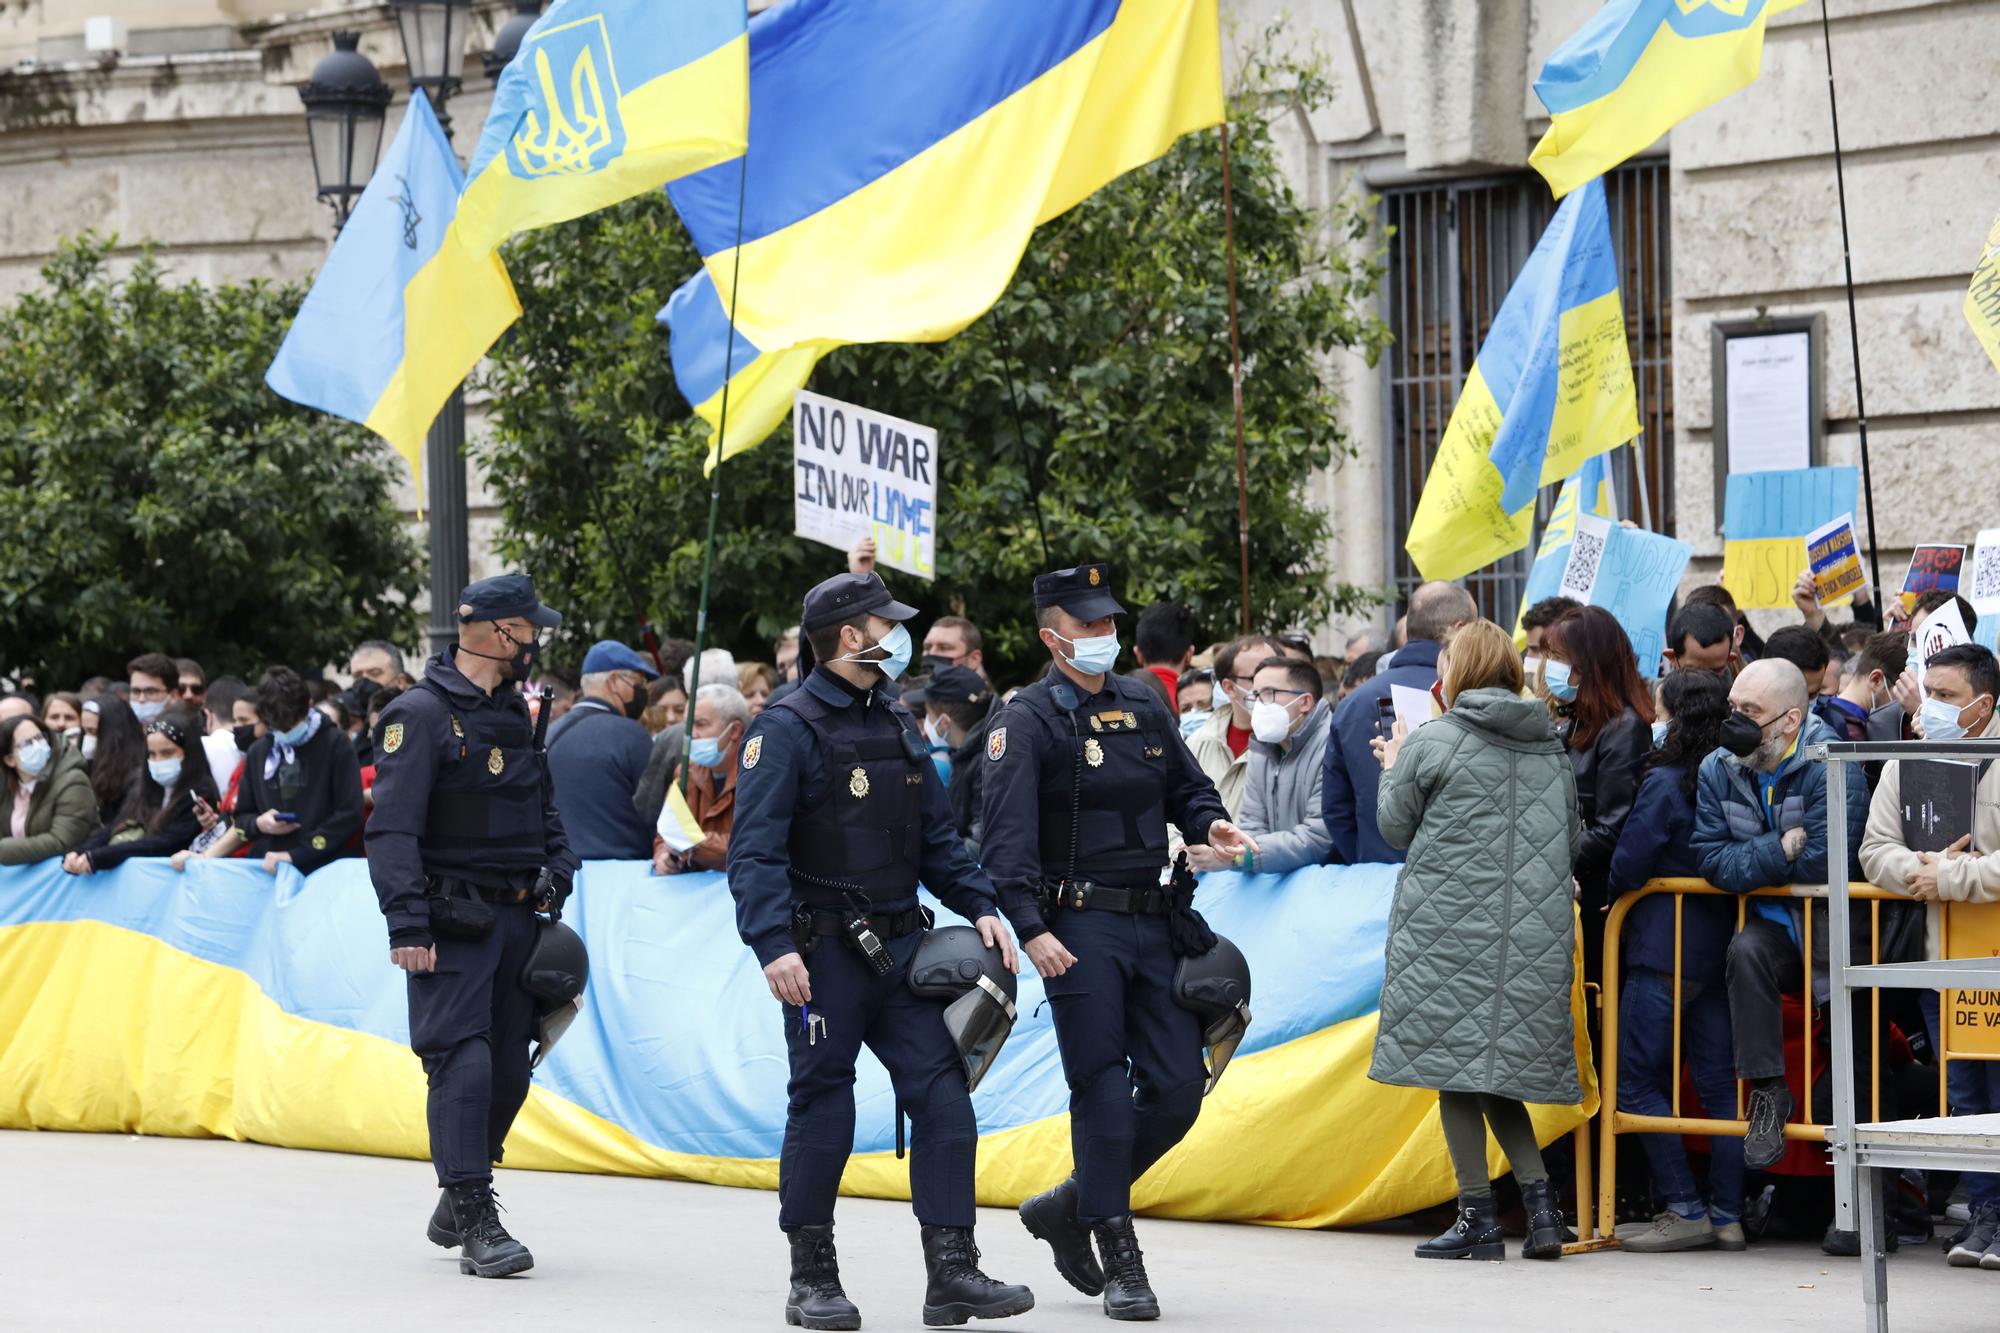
[1694,717,1868,893]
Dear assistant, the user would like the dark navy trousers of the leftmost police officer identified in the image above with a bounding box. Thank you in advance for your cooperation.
[408,903,536,1187]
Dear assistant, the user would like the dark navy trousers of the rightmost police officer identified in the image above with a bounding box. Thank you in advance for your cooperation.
[1046,909,1208,1223]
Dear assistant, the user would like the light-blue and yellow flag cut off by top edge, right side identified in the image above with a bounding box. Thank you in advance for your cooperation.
[1528,0,1800,198]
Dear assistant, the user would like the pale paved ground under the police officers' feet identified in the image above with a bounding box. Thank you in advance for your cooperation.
[0,1133,2000,1333]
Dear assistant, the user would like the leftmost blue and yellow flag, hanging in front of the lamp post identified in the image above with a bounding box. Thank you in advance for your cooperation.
[264,96,520,488]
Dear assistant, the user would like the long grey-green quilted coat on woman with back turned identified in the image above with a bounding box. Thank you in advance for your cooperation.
[1368,691,1582,1107]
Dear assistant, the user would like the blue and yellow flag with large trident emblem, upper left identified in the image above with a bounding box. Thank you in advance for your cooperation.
[458,0,750,252]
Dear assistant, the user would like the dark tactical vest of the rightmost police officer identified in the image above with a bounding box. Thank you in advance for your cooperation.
[1024,683,1180,889]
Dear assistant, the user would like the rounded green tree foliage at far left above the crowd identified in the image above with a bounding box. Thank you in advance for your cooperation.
[0,236,422,689]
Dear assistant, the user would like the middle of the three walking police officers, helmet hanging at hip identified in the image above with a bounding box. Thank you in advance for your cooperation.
[728,572,1034,1329]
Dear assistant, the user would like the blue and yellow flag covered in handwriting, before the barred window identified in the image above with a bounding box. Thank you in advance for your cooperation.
[1404,180,1638,578]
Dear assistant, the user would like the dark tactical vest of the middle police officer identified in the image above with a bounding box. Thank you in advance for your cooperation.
[770,691,930,907]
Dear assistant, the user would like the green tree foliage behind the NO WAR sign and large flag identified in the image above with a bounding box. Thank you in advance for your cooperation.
[486,62,1384,677]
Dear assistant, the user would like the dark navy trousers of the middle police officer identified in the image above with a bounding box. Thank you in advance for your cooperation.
[778,931,980,1231]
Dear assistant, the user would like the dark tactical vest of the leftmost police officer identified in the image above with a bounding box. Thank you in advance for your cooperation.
[416,681,548,877]
